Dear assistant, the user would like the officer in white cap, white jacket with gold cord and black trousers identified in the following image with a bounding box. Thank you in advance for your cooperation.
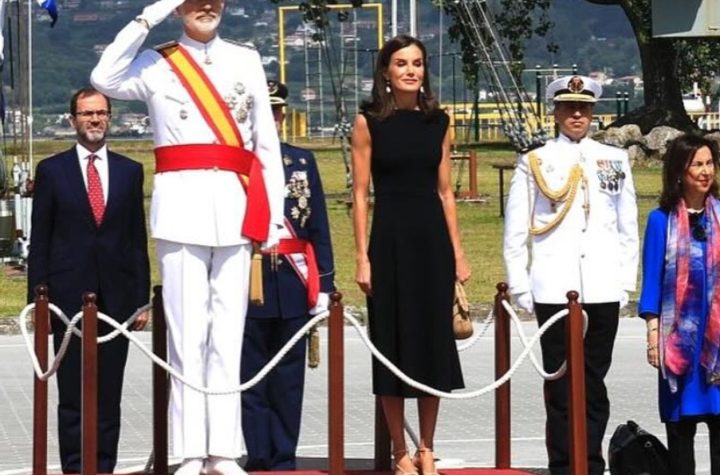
[503,76,638,475]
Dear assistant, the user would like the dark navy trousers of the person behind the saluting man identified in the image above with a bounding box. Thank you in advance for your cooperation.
[240,316,308,471]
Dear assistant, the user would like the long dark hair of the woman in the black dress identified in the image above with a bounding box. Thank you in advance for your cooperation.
[360,35,440,120]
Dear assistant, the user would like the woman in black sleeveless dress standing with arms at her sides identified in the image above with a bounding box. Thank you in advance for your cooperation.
[352,35,470,475]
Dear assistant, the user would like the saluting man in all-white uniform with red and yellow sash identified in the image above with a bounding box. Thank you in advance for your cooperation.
[91,0,284,475]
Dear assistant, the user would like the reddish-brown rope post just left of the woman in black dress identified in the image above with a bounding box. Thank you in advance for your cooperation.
[328,292,345,475]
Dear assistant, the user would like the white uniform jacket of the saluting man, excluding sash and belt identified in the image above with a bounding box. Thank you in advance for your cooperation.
[90,21,284,246]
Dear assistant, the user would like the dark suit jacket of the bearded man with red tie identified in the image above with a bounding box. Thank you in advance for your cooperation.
[28,147,150,330]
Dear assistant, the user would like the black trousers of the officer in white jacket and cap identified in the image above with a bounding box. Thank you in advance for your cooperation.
[535,302,620,475]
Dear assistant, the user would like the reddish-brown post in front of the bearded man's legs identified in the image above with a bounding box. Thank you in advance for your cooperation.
[80,292,98,475]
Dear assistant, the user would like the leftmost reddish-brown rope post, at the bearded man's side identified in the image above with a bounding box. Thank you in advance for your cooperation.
[33,285,50,475]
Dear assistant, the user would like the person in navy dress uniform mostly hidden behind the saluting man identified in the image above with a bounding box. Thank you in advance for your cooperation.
[241,81,335,471]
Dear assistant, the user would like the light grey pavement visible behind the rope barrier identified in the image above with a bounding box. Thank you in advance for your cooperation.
[0,318,710,475]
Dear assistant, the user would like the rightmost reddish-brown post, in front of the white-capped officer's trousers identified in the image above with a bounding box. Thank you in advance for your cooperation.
[565,290,588,475]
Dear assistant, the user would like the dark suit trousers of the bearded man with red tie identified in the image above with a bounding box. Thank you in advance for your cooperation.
[53,322,128,473]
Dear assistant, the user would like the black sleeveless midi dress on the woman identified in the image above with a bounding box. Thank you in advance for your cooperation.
[365,110,464,397]
